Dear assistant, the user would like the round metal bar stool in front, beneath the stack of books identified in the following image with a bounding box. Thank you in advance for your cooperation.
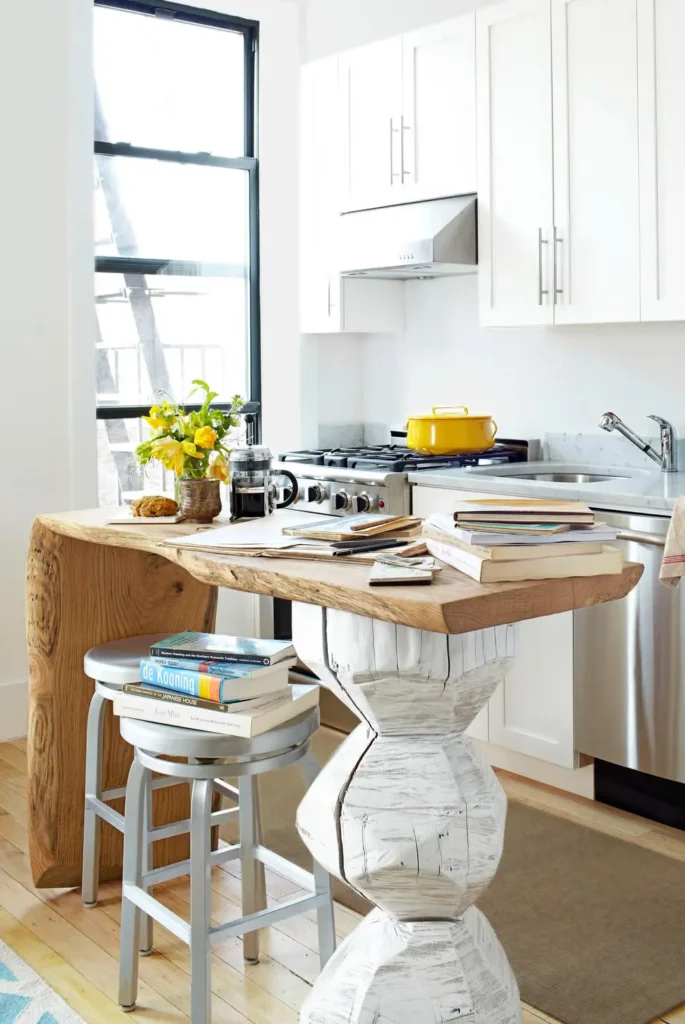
[119,708,335,1024]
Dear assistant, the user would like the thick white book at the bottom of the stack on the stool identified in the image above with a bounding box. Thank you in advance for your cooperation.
[114,684,318,738]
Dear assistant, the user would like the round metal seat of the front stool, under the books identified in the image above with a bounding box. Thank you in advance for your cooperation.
[120,708,318,759]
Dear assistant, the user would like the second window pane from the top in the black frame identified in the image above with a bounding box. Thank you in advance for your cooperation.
[95,154,249,264]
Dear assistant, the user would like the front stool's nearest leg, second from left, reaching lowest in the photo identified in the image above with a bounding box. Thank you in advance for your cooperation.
[190,779,214,1024]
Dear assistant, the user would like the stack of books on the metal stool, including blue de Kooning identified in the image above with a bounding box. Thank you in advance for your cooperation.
[114,631,318,737]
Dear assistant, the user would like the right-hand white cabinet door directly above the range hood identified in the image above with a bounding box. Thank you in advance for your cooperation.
[399,14,477,202]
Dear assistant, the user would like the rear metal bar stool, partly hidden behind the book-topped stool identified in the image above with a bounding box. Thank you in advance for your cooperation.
[81,633,180,955]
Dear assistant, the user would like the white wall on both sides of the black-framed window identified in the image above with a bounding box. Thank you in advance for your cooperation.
[0,0,303,740]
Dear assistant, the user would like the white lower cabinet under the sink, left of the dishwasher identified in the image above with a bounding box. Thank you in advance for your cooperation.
[412,486,577,769]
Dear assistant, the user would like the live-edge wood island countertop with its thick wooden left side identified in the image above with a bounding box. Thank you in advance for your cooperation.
[22,509,643,888]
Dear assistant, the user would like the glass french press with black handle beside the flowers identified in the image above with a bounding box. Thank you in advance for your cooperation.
[228,444,297,522]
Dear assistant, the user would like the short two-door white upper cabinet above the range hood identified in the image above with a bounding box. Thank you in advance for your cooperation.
[341,14,476,210]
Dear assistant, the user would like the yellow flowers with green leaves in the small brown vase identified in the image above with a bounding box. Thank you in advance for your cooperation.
[135,380,244,483]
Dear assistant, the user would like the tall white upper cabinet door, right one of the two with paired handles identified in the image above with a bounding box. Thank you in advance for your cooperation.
[552,0,640,324]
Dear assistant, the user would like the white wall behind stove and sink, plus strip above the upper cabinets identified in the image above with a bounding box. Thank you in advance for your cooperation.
[304,0,685,442]
